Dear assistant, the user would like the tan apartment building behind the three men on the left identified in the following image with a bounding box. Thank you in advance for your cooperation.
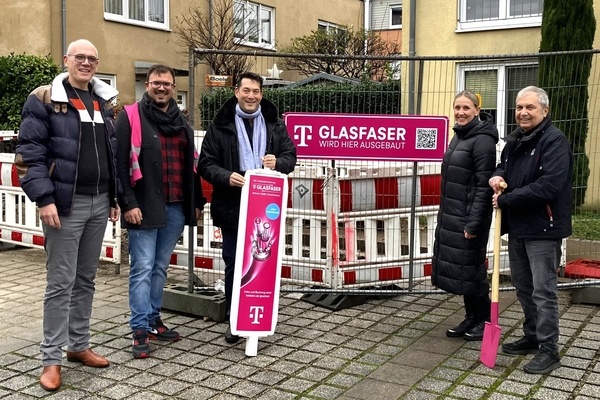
[0,0,363,108]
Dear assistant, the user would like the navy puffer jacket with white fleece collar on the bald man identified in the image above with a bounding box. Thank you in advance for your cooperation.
[15,73,119,216]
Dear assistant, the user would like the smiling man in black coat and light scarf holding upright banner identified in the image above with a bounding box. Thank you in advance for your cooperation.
[198,72,296,343]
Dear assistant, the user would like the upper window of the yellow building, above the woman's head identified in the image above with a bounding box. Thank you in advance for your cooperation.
[458,0,544,31]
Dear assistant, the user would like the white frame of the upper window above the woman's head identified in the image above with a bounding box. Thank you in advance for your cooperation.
[456,0,543,32]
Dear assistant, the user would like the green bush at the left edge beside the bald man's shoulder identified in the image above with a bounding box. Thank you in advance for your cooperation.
[0,53,61,130]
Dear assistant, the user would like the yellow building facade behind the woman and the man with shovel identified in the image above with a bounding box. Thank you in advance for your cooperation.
[402,0,600,207]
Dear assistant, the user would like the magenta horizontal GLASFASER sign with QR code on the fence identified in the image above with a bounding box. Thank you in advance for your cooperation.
[284,112,448,161]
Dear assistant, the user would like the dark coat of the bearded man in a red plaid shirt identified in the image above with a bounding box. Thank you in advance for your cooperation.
[117,95,206,229]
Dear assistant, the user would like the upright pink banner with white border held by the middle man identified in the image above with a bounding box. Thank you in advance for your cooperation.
[230,170,287,336]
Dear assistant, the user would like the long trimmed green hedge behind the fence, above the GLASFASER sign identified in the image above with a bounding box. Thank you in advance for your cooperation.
[199,81,400,130]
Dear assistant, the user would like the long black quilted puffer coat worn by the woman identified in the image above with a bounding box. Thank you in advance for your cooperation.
[431,112,498,296]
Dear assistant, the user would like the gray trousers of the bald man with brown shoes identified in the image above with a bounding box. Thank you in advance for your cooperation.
[40,193,110,366]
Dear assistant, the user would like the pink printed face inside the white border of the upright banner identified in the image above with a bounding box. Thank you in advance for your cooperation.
[237,175,284,332]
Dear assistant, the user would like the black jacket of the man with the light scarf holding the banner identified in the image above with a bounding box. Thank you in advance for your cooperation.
[198,97,296,229]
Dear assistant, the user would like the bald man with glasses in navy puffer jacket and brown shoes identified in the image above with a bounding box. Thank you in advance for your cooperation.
[15,39,119,391]
